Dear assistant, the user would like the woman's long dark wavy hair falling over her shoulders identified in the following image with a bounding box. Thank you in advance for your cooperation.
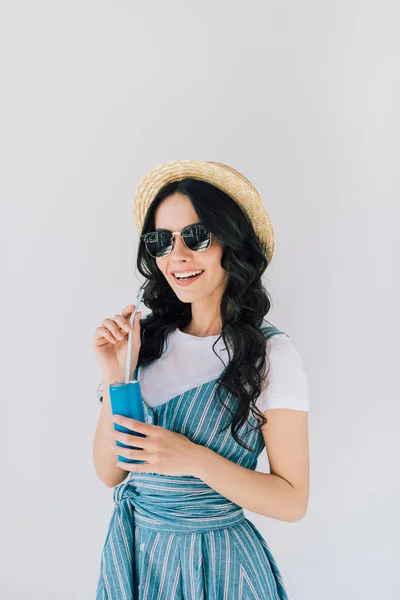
[136,178,271,449]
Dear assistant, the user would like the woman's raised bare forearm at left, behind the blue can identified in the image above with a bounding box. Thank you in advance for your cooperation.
[93,379,128,487]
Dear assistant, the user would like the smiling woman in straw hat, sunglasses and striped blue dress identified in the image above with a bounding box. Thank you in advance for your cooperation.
[94,161,309,600]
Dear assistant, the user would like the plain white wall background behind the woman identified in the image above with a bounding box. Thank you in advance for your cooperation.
[0,0,400,600]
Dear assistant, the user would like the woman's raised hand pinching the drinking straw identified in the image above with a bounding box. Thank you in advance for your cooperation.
[93,304,141,381]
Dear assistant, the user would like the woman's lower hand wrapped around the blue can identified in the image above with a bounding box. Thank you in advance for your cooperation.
[109,415,204,477]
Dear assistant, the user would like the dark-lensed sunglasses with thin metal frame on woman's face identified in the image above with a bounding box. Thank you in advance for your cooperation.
[140,223,211,258]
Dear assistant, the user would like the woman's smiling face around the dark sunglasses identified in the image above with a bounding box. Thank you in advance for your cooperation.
[155,193,228,303]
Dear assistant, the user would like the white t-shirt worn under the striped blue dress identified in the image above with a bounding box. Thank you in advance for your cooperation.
[137,322,309,412]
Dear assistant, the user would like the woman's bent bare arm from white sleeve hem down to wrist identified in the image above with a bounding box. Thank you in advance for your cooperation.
[195,408,309,522]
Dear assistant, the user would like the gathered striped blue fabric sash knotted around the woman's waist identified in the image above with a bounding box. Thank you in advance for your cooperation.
[113,473,245,534]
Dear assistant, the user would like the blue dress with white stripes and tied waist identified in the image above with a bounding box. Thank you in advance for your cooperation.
[96,327,288,600]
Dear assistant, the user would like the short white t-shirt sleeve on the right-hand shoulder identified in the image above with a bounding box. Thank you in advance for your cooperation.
[256,333,309,412]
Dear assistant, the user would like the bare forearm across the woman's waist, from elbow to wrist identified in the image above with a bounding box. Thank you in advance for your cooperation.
[193,446,303,522]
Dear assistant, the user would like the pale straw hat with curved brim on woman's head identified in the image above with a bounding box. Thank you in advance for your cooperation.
[133,160,275,263]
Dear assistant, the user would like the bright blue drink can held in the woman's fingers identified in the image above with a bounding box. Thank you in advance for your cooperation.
[109,379,146,465]
